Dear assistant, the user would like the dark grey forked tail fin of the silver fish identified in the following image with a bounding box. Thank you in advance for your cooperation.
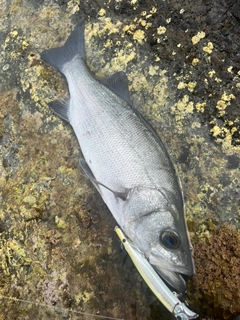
[41,22,85,72]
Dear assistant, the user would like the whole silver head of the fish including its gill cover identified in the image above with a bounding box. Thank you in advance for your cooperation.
[126,186,194,293]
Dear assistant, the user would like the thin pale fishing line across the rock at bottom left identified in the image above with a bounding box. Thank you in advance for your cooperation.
[0,295,124,320]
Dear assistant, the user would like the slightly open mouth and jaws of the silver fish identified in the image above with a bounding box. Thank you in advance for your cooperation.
[149,249,194,293]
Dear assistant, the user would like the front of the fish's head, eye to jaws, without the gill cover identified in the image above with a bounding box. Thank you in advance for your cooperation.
[130,212,194,293]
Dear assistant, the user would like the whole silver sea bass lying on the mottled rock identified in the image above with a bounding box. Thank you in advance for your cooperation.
[41,23,194,292]
